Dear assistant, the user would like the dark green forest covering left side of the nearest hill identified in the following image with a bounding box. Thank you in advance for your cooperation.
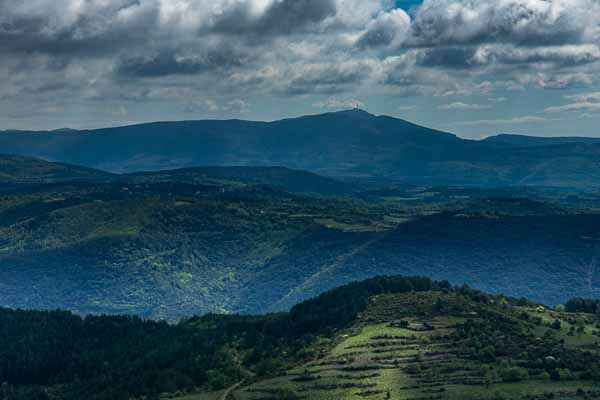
[0,277,450,400]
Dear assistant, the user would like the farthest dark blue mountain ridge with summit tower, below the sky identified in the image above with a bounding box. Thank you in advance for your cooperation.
[0,110,600,188]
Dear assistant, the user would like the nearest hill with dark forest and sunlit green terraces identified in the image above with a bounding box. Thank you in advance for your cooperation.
[0,276,600,400]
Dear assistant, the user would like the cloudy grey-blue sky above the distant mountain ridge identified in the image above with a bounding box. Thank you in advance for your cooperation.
[0,0,600,138]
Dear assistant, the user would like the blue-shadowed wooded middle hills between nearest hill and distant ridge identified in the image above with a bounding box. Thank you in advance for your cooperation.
[0,154,600,321]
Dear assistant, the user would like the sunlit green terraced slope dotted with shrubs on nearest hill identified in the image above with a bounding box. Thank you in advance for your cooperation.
[190,292,600,400]
